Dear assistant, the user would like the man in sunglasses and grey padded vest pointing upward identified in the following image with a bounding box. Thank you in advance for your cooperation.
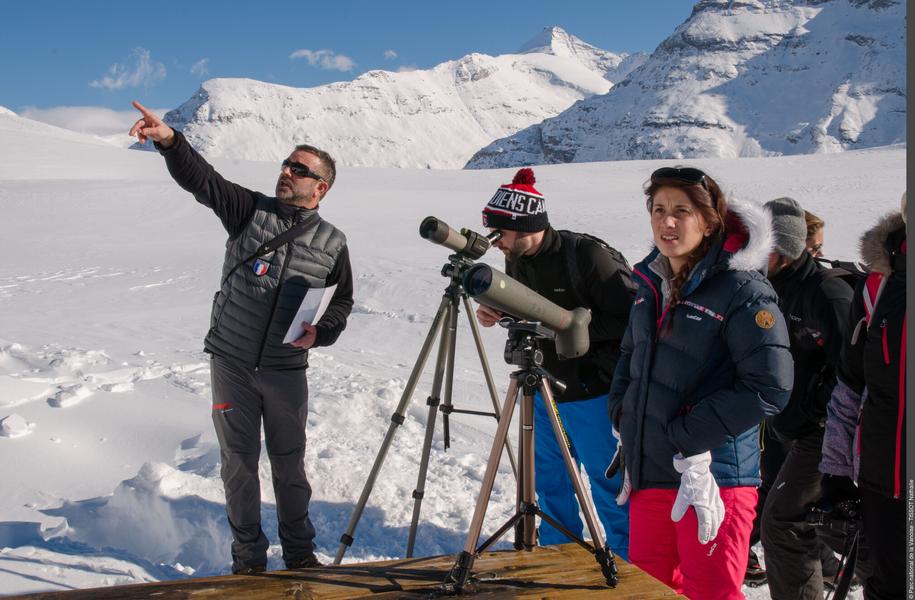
[130,102,353,574]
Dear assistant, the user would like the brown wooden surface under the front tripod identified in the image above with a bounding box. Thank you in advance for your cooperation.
[16,544,682,600]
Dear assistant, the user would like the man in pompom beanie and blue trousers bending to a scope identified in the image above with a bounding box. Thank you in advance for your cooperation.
[477,169,635,559]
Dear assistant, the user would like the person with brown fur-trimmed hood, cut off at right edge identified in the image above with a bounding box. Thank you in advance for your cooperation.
[820,194,907,600]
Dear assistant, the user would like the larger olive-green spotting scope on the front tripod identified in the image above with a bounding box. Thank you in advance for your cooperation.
[464,264,591,359]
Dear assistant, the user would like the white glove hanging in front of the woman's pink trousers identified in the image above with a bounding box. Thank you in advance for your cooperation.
[670,452,724,544]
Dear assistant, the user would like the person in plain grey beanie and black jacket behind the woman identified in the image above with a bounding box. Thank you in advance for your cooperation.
[760,198,852,600]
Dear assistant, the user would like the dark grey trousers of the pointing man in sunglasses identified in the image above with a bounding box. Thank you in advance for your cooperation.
[210,356,315,570]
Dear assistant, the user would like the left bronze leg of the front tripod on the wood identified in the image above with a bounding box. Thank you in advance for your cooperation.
[442,375,518,592]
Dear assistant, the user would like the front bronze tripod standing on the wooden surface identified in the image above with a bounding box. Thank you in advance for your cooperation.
[442,323,618,594]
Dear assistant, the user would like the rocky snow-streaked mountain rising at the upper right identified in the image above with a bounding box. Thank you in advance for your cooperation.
[467,0,906,168]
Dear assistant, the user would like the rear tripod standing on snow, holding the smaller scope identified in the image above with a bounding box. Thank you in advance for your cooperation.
[334,252,518,565]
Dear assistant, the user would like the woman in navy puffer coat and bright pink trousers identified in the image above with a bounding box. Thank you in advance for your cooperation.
[610,167,793,600]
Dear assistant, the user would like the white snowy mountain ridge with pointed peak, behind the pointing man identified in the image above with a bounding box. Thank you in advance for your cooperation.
[157,27,644,168]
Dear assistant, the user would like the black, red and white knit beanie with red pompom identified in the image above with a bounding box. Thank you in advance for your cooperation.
[483,169,550,236]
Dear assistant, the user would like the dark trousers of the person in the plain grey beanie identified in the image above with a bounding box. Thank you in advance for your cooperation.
[760,431,823,600]
